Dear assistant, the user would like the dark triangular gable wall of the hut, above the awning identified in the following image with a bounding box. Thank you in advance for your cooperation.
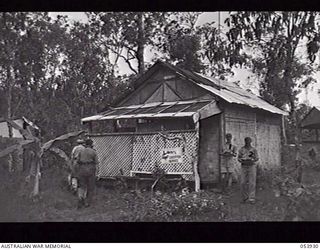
[120,65,213,106]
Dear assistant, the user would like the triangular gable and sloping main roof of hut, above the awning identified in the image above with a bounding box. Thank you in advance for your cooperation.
[117,61,288,115]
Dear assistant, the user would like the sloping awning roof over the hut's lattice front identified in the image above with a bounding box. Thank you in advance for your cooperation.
[81,100,221,123]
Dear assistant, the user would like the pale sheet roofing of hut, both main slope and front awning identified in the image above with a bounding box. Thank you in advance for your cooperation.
[87,61,288,122]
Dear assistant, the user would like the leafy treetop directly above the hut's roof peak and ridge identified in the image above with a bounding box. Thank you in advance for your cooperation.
[155,12,239,78]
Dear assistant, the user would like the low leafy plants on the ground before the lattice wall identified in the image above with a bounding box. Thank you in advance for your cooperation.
[119,188,224,222]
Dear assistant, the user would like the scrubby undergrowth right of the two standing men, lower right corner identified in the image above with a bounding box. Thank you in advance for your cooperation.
[257,147,320,221]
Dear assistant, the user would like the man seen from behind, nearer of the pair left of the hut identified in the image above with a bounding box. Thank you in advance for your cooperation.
[76,139,98,208]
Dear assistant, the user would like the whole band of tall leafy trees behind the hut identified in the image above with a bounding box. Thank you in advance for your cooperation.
[0,12,319,144]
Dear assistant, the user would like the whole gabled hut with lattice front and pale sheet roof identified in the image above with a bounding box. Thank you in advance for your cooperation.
[82,61,287,187]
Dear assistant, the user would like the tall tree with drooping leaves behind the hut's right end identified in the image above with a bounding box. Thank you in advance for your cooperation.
[226,11,319,113]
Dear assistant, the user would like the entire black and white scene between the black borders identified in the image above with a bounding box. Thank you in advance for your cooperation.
[0,11,320,227]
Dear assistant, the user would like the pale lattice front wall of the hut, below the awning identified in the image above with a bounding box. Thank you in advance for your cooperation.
[91,130,198,180]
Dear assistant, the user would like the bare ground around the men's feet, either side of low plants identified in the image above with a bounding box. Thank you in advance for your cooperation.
[0,165,320,222]
